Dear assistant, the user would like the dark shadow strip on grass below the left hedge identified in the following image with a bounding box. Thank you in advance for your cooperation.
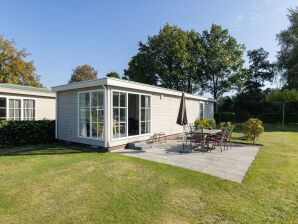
[0,145,102,156]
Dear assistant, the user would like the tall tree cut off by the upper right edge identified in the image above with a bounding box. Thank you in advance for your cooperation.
[277,7,298,90]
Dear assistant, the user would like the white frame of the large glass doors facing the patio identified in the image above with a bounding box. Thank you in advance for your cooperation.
[110,89,152,141]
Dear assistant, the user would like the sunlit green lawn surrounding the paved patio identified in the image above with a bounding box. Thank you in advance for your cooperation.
[0,125,298,224]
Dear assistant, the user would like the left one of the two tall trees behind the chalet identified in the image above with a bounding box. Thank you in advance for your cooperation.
[124,24,203,93]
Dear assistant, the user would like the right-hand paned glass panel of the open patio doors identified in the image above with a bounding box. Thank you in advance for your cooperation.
[141,95,151,134]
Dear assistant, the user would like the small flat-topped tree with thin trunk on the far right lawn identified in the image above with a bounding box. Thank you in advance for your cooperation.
[267,89,298,129]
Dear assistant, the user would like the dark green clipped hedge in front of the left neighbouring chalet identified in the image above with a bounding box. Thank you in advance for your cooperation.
[0,120,55,148]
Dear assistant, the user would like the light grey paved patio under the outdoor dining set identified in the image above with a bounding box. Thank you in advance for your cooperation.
[114,140,260,183]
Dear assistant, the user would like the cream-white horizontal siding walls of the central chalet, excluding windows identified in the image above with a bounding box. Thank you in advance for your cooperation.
[57,86,213,147]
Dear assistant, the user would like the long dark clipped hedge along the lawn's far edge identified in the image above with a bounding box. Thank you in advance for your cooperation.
[214,112,298,123]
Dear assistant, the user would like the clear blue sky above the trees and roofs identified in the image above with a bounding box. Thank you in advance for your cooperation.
[0,0,298,88]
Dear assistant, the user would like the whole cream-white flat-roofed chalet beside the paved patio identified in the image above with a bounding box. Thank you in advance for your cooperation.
[52,78,215,150]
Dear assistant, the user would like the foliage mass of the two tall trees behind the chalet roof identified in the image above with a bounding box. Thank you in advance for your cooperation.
[124,24,244,99]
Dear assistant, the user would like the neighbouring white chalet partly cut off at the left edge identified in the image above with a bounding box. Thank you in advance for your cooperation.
[0,83,56,120]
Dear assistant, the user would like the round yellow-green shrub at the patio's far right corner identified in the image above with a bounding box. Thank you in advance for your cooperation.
[243,118,264,145]
